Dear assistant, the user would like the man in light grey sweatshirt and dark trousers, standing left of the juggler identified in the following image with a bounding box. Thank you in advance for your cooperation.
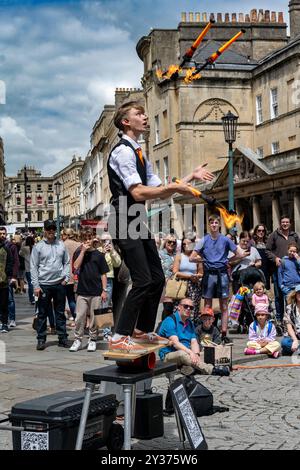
[30,220,70,351]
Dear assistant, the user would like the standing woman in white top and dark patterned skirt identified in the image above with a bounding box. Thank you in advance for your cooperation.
[173,238,203,322]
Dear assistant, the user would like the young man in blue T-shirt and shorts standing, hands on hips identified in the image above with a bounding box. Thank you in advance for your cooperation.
[190,215,244,343]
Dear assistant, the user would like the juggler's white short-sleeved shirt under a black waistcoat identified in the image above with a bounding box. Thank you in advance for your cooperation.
[109,135,162,191]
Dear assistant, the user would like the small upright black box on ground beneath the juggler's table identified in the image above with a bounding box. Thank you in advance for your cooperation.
[133,393,164,440]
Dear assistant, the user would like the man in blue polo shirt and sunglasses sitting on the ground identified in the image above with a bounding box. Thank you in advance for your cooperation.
[158,298,230,375]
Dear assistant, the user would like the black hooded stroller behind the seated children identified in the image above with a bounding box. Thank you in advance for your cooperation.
[230,266,283,336]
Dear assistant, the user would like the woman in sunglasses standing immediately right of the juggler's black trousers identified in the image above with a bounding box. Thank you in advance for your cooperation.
[159,234,177,320]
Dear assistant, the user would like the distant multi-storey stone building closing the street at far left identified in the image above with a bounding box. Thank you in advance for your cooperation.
[5,167,54,229]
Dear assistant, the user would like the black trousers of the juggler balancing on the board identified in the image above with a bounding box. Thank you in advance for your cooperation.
[116,239,165,336]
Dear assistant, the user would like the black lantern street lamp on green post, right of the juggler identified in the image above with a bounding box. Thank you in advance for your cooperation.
[222,111,238,211]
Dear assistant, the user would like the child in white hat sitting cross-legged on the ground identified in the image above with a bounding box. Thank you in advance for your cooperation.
[244,304,280,358]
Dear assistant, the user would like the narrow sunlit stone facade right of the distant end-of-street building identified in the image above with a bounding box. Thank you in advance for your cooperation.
[53,155,84,230]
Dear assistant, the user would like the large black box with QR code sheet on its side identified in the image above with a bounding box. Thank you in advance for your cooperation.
[9,390,124,450]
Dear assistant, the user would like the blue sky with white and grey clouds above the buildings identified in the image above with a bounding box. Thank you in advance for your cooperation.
[0,0,288,176]
